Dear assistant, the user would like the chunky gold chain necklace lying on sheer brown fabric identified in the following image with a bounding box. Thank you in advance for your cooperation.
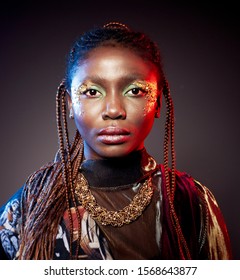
[75,173,153,227]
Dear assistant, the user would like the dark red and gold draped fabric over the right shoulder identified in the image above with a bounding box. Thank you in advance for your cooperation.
[156,166,232,259]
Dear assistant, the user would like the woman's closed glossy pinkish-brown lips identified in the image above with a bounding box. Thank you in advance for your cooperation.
[97,127,130,145]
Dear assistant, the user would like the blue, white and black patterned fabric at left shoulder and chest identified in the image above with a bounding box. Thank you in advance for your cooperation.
[0,192,112,259]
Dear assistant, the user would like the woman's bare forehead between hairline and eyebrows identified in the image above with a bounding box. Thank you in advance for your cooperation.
[73,46,157,86]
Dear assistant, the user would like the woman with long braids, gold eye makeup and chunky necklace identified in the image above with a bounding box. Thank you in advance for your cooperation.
[0,22,231,259]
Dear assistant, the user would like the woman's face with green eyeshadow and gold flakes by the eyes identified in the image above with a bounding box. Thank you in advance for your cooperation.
[69,47,160,159]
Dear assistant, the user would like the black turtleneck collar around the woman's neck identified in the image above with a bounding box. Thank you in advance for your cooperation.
[80,148,156,187]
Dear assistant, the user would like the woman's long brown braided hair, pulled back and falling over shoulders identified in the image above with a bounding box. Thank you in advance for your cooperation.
[18,22,191,259]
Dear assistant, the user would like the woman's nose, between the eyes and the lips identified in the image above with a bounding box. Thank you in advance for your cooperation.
[102,95,126,120]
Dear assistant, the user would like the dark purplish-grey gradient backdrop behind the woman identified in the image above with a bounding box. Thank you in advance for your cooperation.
[0,0,240,259]
